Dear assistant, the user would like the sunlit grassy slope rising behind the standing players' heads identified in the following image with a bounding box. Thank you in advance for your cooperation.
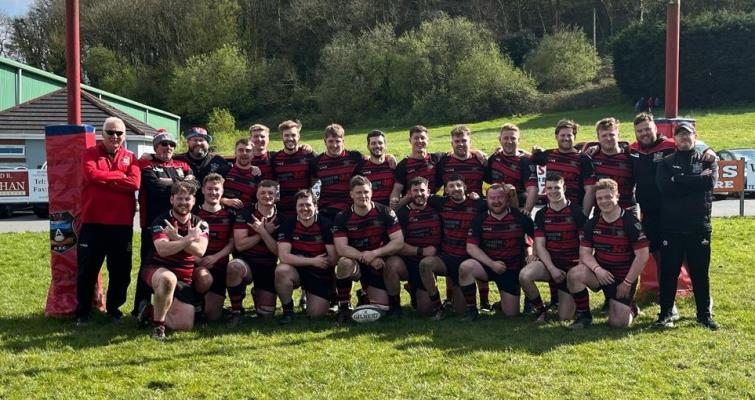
[204,105,755,159]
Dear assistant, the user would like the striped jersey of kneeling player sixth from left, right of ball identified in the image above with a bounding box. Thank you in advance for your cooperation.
[396,205,443,259]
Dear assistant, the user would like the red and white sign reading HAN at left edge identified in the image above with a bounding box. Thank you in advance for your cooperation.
[0,169,47,203]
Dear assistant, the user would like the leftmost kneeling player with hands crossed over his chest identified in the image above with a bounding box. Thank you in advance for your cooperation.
[139,182,209,341]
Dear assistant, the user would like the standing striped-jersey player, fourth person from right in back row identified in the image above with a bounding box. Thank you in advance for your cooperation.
[530,120,595,216]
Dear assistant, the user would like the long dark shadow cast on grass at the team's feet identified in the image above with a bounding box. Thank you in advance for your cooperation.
[0,307,651,360]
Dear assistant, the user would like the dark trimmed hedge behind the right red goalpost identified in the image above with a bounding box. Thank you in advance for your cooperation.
[611,11,755,107]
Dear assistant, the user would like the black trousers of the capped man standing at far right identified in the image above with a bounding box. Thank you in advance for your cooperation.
[660,232,710,318]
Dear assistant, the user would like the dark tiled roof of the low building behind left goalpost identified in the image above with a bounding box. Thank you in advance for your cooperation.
[0,87,155,142]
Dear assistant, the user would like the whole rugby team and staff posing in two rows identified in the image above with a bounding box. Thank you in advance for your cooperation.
[75,112,719,341]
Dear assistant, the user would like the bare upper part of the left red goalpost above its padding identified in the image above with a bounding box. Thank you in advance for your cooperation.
[66,0,81,125]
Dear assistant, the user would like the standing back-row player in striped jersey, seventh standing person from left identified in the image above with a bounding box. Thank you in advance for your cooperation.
[312,124,364,219]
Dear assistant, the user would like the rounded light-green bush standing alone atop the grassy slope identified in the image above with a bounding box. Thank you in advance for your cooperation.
[524,28,600,92]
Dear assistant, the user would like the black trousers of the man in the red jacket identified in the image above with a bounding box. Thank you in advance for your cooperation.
[76,224,134,317]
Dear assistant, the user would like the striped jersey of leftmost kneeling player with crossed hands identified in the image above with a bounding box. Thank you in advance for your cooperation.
[148,210,210,284]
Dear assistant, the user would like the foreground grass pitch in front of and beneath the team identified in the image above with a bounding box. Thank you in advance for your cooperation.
[0,220,755,399]
